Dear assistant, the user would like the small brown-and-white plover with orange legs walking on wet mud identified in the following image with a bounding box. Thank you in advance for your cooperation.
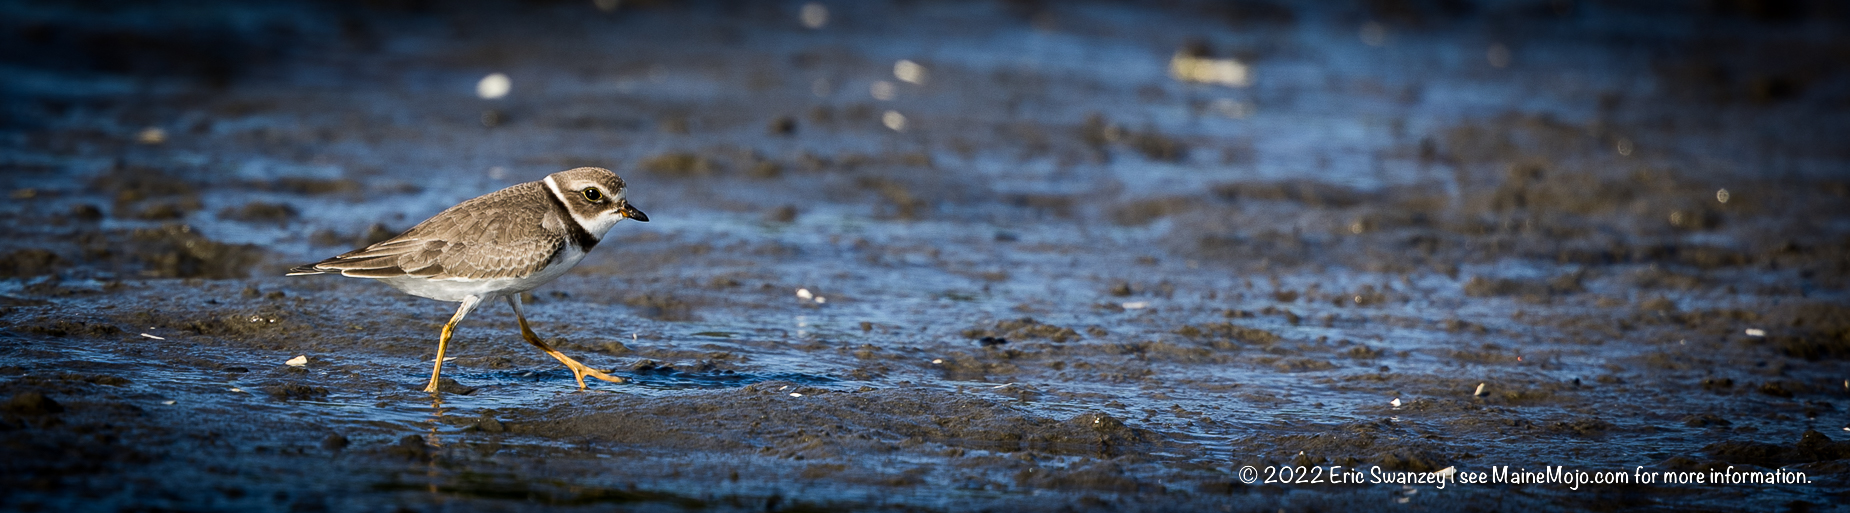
[289,167,649,393]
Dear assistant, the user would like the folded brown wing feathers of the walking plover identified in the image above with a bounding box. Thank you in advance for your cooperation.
[290,181,566,280]
